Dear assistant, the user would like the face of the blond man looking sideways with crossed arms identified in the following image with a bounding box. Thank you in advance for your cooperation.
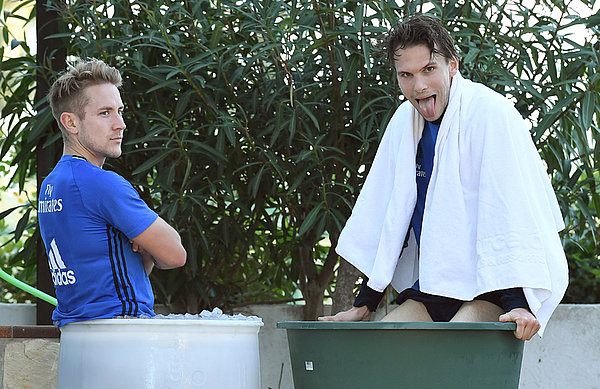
[78,84,125,166]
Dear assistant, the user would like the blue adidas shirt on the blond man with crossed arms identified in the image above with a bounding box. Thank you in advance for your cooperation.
[38,155,158,327]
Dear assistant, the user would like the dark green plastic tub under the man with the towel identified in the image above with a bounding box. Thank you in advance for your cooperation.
[277,321,524,389]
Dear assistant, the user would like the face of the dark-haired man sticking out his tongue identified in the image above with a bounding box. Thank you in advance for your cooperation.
[394,45,458,122]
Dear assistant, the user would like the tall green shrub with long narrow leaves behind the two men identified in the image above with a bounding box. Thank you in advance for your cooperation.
[0,0,600,318]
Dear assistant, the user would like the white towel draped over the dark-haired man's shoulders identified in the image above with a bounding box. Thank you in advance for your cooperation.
[336,74,568,336]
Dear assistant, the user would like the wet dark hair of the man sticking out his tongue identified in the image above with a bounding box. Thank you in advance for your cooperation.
[384,14,458,66]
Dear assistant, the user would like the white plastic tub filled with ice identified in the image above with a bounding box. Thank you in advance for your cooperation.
[58,319,263,389]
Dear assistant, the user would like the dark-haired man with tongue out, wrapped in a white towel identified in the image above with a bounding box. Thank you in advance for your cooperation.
[319,15,566,340]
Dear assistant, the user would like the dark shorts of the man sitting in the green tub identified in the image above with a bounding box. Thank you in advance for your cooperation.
[396,288,502,321]
